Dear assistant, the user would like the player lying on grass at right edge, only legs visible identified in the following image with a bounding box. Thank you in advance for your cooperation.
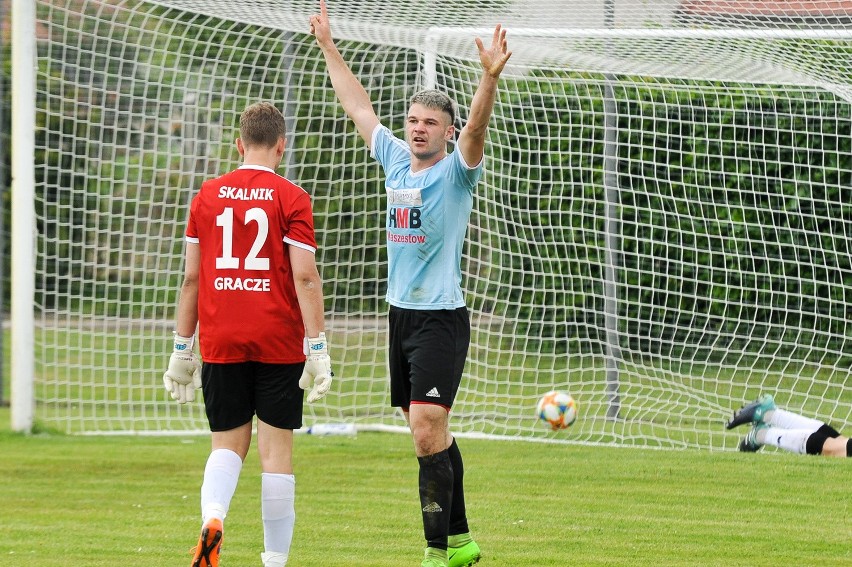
[726,394,852,457]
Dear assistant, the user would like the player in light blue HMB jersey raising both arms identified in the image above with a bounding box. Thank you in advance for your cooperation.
[310,0,511,567]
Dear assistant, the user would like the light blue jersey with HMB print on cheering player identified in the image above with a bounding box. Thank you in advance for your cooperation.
[370,125,482,309]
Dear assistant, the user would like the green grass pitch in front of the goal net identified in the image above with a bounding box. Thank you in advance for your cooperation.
[0,409,852,567]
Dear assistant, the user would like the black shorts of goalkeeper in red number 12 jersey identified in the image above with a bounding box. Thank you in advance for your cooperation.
[201,362,305,431]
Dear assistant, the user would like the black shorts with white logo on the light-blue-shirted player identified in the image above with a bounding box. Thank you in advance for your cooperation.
[388,306,470,410]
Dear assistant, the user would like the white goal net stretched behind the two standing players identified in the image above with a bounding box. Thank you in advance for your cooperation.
[18,0,852,449]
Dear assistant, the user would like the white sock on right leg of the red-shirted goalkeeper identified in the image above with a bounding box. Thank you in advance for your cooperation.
[260,473,296,559]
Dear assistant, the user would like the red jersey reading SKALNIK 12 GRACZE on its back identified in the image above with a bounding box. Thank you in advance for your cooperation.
[186,165,317,364]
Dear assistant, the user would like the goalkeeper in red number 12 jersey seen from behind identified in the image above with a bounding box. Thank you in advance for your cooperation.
[163,103,332,567]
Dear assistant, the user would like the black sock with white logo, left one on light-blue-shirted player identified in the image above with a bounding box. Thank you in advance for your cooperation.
[417,451,453,549]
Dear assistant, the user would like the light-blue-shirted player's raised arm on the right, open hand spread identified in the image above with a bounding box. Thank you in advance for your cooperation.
[458,24,512,165]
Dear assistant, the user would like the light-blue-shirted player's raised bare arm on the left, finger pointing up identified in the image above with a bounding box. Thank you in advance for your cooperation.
[310,0,379,146]
